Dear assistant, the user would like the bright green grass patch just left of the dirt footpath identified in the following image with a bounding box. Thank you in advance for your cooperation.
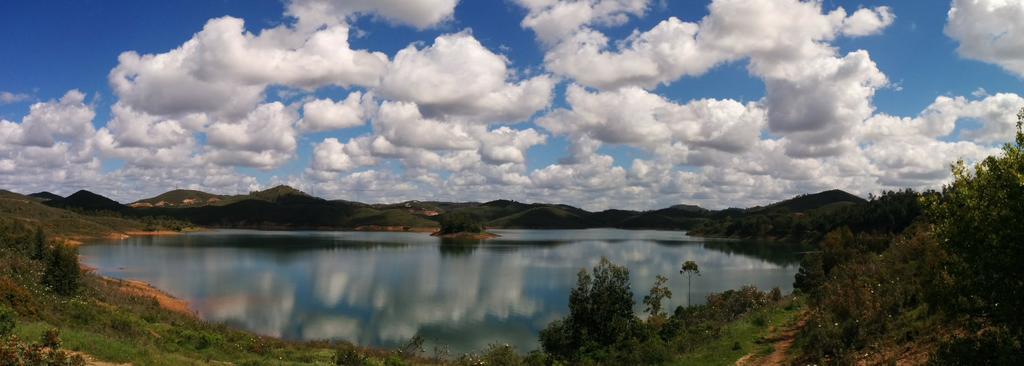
[673,298,803,365]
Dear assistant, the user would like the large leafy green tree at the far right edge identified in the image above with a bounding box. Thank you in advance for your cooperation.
[927,105,1024,352]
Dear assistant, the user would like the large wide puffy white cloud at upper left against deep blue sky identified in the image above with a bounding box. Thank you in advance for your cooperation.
[110,16,387,117]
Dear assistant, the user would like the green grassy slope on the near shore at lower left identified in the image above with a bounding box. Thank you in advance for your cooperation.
[4,275,415,365]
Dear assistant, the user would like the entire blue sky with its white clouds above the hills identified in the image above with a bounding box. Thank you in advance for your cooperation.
[0,0,1024,209]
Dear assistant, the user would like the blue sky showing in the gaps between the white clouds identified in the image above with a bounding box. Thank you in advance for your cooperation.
[0,0,1022,207]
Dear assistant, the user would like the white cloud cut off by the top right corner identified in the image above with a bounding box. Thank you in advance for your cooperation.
[945,0,1024,76]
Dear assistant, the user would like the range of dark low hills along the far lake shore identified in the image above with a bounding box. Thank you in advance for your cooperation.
[0,186,865,231]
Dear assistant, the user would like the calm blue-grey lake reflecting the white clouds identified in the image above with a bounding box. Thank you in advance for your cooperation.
[81,229,800,355]
